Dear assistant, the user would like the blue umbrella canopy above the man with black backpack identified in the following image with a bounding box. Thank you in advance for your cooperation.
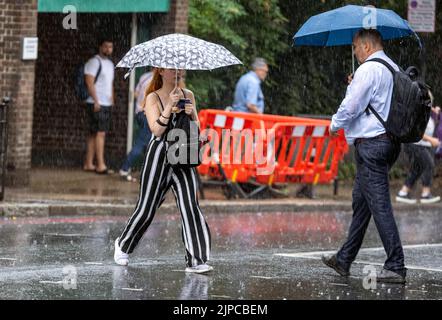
[293,5,415,46]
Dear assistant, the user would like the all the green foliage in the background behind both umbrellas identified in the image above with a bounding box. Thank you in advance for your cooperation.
[188,0,442,115]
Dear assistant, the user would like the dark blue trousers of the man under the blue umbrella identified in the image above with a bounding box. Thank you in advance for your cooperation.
[337,136,406,276]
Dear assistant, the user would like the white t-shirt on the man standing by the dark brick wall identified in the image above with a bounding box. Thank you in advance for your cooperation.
[84,54,115,107]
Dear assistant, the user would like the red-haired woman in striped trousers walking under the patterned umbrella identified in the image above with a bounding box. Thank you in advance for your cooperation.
[114,68,213,273]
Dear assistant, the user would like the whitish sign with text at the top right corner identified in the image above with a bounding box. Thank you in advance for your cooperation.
[408,0,436,32]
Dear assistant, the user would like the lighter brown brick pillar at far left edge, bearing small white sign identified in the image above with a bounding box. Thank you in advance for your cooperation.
[0,0,37,185]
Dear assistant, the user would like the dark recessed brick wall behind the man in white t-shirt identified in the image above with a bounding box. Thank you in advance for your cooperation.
[32,13,132,167]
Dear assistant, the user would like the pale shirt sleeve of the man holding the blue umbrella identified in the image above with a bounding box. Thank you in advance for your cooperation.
[330,65,375,131]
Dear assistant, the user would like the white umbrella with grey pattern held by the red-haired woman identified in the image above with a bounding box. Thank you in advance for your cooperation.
[117,33,242,77]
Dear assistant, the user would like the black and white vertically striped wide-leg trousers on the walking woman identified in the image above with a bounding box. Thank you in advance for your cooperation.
[119,139,211,267]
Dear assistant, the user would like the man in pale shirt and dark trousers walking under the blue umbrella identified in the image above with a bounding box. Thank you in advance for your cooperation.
[322,29,407,283]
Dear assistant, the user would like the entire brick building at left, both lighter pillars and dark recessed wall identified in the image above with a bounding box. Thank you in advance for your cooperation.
[0,0,188,175]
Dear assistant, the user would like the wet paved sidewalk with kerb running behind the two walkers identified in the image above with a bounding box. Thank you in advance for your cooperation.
[0,168,442,217]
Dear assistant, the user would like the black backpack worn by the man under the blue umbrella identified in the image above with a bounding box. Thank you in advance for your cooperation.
[366,58,431,143]
